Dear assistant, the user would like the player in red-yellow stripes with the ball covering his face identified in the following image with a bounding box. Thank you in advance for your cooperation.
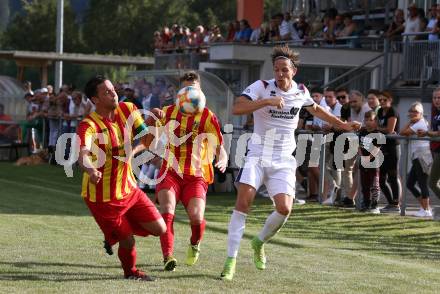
[150,72,227,271]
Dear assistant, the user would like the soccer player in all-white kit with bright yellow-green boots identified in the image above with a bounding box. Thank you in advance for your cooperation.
[221,46,361,280]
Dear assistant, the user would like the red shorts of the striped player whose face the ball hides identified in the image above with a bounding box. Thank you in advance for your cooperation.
[156,169,208,207]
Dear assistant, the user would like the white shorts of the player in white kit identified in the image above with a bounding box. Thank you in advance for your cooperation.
[235,157,296,197]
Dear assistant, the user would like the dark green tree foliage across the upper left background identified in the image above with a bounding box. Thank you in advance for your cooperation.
[2,0,281,55]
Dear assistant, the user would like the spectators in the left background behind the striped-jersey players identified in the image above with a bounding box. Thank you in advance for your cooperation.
[0,78,176,177]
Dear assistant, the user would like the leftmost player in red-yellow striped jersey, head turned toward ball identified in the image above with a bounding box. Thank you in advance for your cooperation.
[77,76,166,281]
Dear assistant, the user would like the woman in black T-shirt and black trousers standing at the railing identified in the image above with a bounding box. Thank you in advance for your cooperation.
[377,91,402,212]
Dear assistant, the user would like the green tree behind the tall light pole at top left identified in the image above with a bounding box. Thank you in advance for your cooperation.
[2,0,82,52]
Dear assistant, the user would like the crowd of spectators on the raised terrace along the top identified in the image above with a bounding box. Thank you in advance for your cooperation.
[154,4,440,53]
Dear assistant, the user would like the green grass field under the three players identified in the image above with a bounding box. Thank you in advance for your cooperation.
[0,163,440,293]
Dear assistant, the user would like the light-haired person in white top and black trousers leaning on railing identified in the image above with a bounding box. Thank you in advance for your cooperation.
[400,102,432,217]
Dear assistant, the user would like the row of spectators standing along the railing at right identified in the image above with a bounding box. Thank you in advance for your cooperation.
[290,87,440,217]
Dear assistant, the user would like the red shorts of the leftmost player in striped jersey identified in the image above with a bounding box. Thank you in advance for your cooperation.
[85,188,162,245]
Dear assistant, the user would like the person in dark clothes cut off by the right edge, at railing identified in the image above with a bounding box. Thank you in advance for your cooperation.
[417,87,440,210]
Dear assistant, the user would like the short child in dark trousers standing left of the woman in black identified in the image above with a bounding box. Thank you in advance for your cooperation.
[359,110,380,214]
